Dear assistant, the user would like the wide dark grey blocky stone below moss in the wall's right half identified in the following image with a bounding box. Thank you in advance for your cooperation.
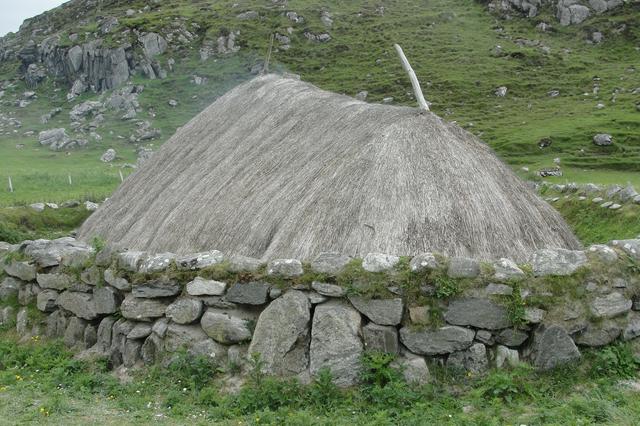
[444,298,511,330]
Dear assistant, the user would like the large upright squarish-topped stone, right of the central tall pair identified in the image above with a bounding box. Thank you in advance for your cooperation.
[309,300,363,386]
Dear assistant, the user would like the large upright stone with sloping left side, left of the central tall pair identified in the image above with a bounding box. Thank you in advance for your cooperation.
[249,290,311,376]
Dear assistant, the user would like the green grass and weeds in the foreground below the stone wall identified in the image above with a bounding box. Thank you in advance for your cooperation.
[0,331,640,425]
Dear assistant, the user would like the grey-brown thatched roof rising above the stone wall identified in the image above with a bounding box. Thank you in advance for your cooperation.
[80,75,579,260]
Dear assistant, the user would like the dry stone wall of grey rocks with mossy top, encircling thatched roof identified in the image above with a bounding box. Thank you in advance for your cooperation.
[0,238,640,386]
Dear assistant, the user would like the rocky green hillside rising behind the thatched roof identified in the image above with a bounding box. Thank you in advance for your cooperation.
[0,0,640,205]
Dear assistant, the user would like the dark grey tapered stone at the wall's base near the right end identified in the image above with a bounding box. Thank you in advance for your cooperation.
[532,325,582,371]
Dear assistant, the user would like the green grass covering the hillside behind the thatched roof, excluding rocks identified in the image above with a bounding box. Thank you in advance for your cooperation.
[0,0,640,206]
